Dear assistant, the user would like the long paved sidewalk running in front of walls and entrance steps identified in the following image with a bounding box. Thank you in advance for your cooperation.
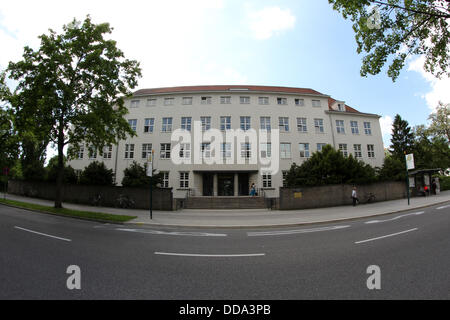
[0,191,450,228]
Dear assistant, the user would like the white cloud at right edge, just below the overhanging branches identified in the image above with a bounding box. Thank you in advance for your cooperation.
[408,56,450,112]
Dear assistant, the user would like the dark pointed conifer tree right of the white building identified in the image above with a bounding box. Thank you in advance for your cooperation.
[390,114,414,163]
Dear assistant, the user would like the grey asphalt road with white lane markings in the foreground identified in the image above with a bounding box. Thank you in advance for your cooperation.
[0,203,450,300]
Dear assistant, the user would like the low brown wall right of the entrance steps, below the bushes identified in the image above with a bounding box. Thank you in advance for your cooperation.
[278,182,407,210]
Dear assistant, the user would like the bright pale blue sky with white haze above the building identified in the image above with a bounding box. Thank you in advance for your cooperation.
[0,0,450,153]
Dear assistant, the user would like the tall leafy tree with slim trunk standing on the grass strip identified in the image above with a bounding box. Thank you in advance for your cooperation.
[7,16,141,208]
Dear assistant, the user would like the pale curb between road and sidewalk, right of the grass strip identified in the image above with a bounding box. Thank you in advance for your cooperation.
[123,199,450,229]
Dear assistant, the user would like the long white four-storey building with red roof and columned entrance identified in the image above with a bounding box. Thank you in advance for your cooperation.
[70,85,384,198]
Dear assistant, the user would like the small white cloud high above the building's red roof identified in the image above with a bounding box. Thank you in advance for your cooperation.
[247,7,295,40]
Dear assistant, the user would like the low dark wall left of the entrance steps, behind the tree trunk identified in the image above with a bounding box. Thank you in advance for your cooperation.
[8,180,173,211]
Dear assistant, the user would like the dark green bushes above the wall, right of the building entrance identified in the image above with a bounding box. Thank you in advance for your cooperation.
[286,145,376,187]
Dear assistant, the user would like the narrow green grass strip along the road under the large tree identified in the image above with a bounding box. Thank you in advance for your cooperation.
[0,199,136,222]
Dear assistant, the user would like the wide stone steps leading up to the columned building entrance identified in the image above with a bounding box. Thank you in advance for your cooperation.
[184,196,266,209]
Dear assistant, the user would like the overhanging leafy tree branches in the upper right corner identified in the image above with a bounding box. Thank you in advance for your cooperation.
[328,0,450,81]
